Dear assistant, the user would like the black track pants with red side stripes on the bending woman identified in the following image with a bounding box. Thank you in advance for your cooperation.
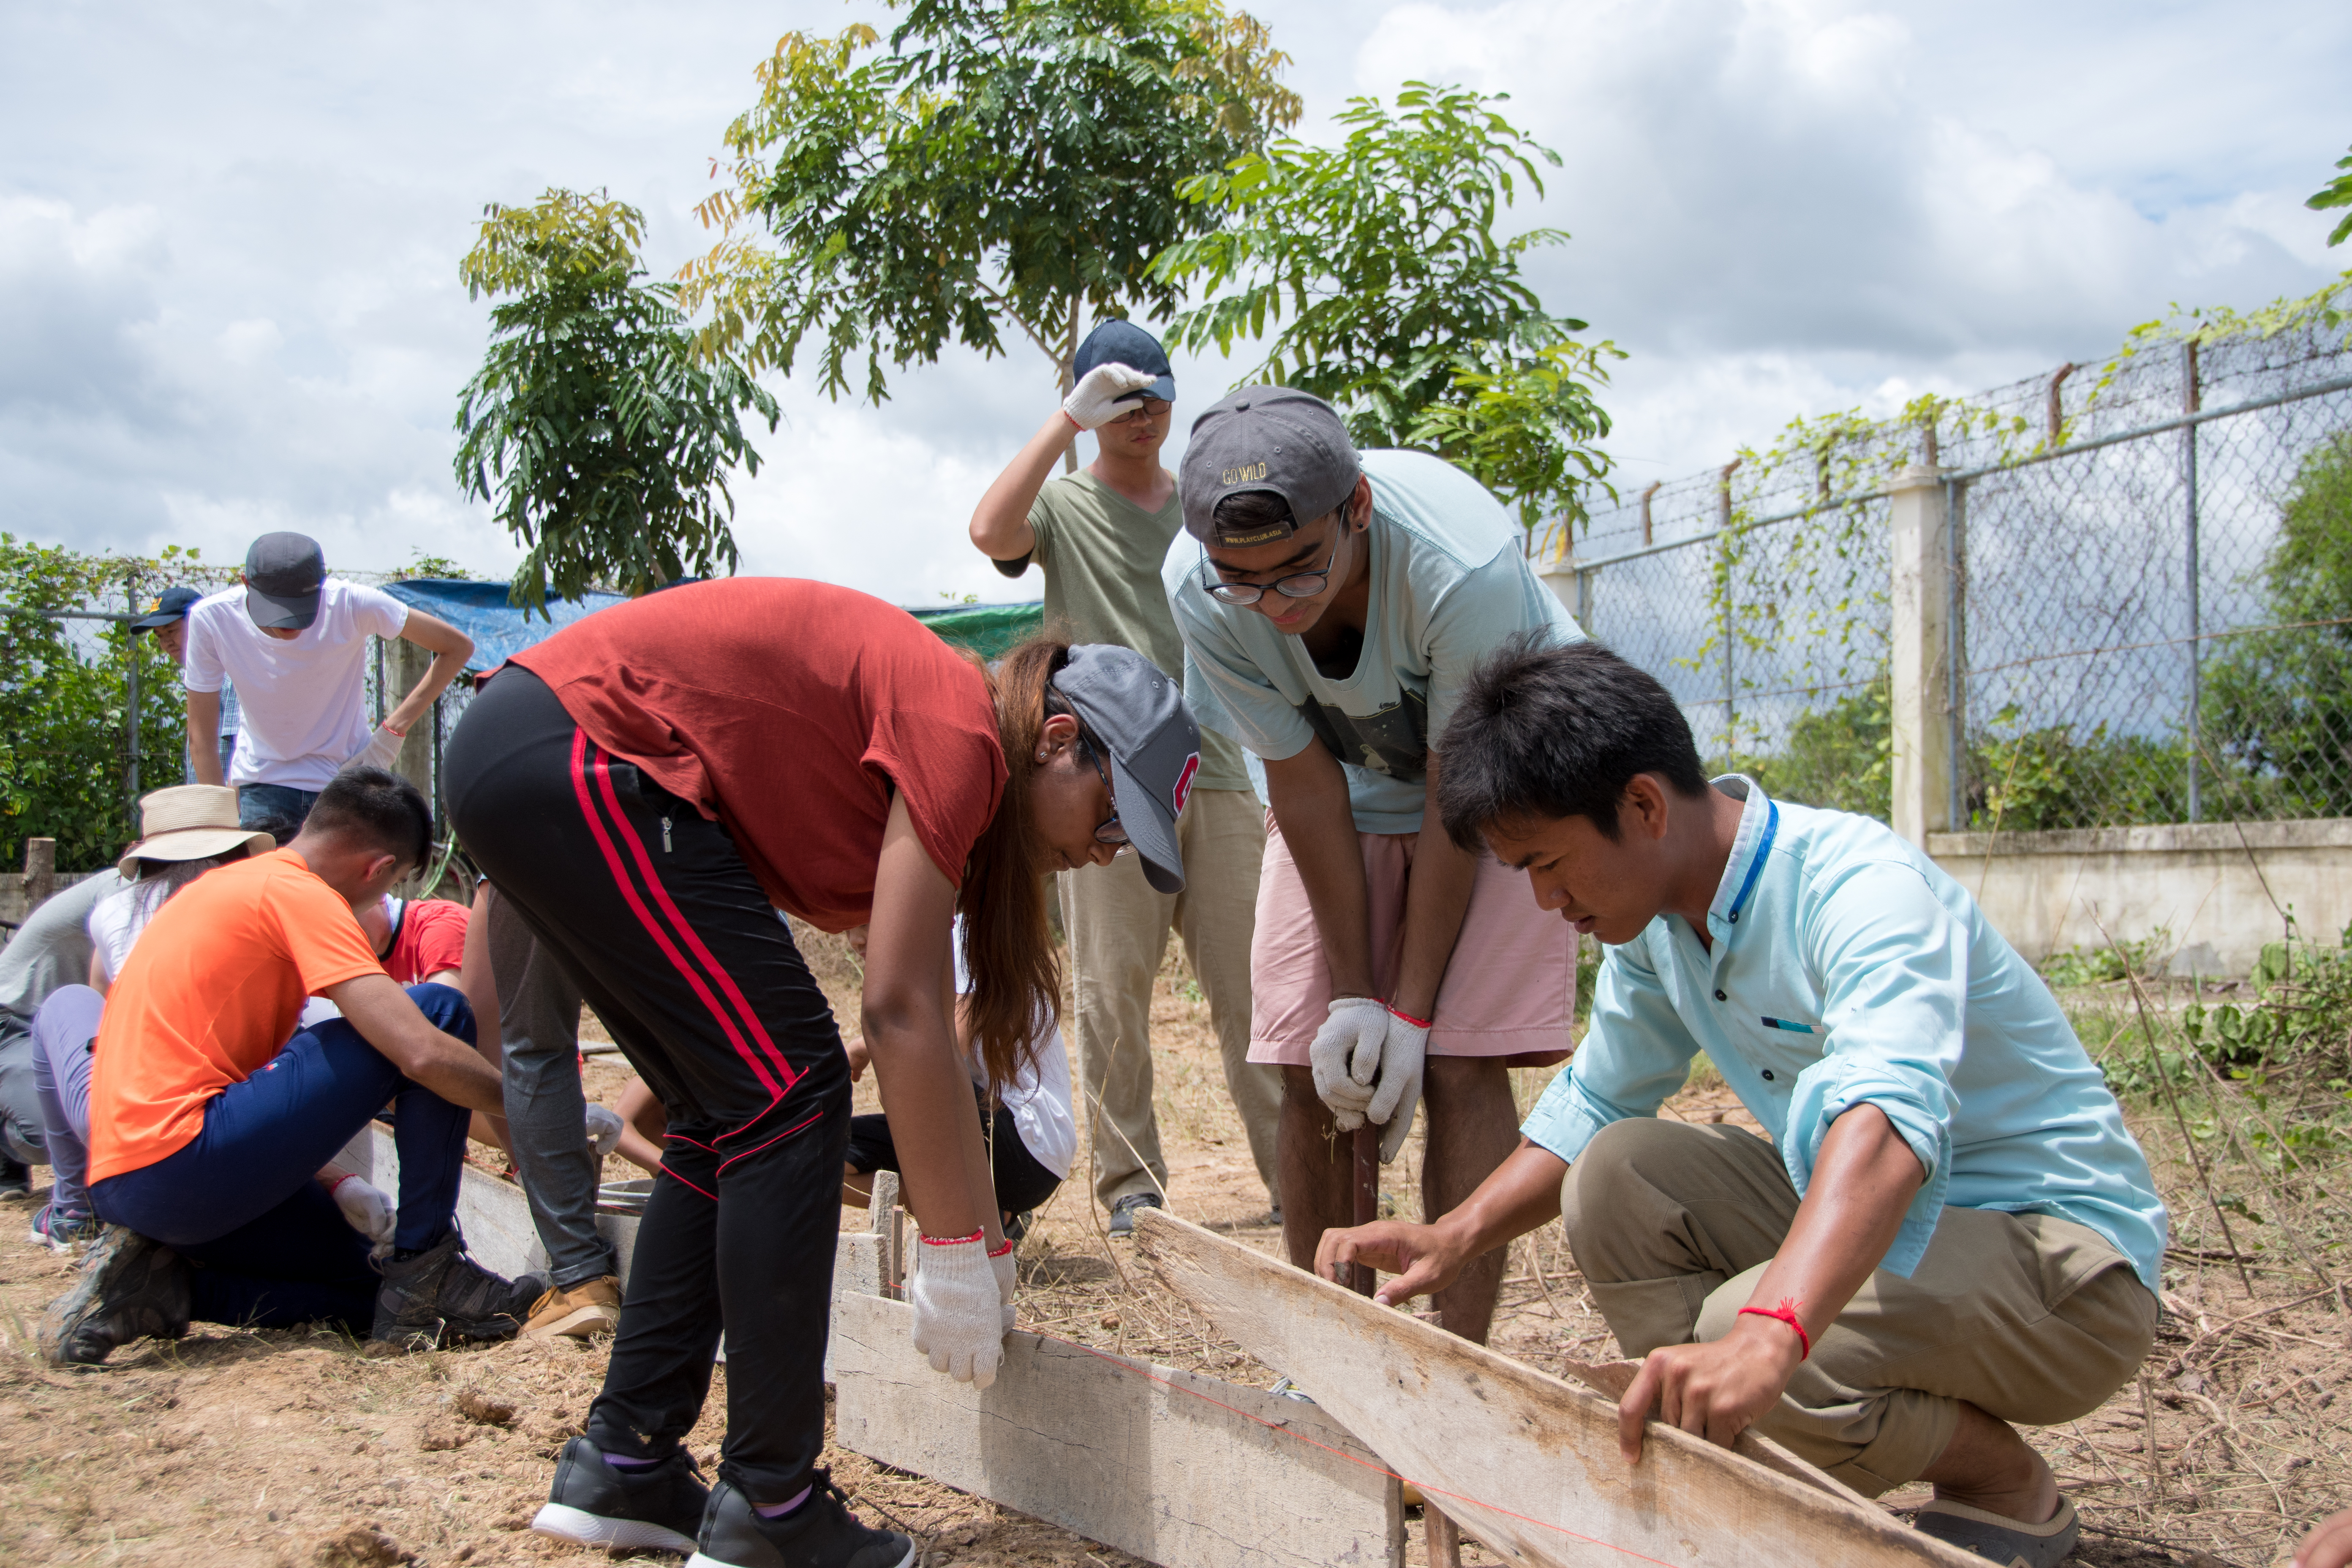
[444,665,849,1502]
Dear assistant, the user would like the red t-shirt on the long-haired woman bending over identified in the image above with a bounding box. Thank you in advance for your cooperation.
[513,578,1004,931]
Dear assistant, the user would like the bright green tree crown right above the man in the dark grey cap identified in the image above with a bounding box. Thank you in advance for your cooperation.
[1155,82,1623,541]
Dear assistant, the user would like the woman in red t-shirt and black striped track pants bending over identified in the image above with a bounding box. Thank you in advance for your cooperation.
[444,578,1200,1568]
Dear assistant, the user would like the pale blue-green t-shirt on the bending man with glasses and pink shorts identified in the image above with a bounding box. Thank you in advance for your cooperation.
[1164,452,1583,832]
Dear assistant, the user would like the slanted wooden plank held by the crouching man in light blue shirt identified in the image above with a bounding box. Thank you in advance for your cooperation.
[1136,1211,1983,1568]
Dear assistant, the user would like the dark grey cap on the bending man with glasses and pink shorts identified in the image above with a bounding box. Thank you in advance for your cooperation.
[1176,386,1364,548]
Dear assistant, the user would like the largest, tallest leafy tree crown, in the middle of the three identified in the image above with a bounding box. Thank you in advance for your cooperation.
[682,0,1298,416]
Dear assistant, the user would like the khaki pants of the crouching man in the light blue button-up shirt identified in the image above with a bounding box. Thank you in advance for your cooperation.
[1560,1116,2157,1497]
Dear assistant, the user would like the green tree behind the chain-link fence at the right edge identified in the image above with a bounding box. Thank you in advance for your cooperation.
[2202,430,2352,816]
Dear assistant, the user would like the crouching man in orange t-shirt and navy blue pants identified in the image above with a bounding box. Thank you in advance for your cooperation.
[40,769,541,1366]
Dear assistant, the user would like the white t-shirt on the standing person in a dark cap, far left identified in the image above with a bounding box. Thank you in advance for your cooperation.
[186,578,409,790]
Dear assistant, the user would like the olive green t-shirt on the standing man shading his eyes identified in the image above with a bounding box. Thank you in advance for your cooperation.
[1021,470,1249,790]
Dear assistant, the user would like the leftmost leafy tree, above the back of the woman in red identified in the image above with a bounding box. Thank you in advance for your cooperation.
[456,191,779,611]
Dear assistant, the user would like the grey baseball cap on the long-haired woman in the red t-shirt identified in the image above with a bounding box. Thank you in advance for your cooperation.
[1054,642,1200,893]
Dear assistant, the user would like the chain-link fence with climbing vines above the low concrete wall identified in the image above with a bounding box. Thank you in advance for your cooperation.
[1536,327,2352,830]
